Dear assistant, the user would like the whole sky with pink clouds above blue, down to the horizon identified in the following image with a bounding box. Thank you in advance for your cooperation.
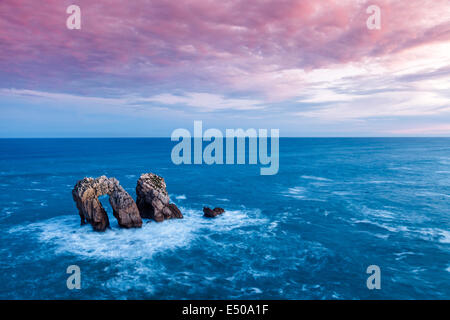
[0,0,450,137]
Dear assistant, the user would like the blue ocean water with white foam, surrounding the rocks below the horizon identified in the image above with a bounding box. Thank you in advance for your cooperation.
[0,138,450,299]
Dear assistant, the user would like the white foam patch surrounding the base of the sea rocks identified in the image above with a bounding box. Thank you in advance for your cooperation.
[9,207,268,259]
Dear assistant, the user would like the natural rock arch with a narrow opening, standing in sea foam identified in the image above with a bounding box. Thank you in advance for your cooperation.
[72,176,142,231]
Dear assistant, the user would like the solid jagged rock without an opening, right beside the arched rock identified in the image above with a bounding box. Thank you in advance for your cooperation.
[136,173,183,222]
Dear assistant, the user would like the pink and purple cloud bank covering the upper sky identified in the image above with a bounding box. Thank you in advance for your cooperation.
[0,0,450,93]
